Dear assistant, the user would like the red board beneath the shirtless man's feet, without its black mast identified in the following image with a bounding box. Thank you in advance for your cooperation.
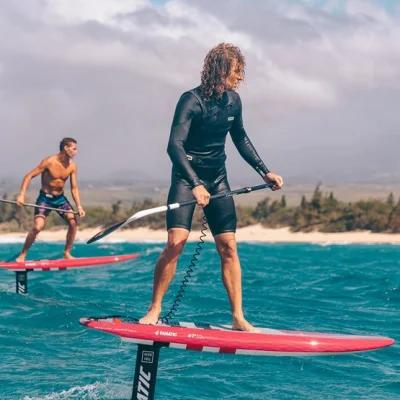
[0,254,139,271]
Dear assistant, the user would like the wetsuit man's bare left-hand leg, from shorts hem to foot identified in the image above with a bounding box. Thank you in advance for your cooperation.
[139,228,189,325]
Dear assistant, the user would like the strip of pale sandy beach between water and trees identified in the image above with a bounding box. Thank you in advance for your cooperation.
[0,224,400,244]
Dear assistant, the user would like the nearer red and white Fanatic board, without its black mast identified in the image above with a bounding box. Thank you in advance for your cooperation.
[80,317,394,356]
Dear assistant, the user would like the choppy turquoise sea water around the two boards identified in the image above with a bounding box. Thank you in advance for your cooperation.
[0,239,400,400]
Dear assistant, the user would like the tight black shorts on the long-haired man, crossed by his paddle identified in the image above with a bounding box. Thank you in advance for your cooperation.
[167,166,236,236]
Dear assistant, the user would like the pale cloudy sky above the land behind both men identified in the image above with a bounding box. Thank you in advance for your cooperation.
[0,0,400,184]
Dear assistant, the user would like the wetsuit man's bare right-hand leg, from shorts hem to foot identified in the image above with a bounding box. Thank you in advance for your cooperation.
[214,232,258,332]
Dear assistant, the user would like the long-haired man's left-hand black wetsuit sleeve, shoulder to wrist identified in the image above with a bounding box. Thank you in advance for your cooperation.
[167,93,203,188]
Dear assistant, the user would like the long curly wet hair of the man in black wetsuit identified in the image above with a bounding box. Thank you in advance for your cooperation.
[201,43,246,101]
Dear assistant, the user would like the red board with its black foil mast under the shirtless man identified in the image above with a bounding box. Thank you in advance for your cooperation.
[0,254,139,294]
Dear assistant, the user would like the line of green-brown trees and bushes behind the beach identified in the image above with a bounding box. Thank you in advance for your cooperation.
[0,185,400,233]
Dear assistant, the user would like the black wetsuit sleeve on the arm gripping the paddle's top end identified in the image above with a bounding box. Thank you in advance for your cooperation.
[230,98,269,177]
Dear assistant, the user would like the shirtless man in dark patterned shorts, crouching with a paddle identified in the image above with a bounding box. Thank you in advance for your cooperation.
[16,138,85,262]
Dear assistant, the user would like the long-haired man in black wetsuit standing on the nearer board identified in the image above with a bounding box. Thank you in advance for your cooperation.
[140,43,283,332]
